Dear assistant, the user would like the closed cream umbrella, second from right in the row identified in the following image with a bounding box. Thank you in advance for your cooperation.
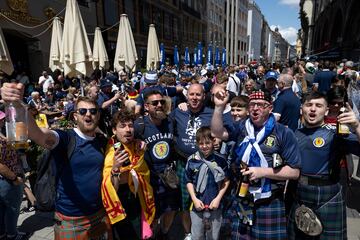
[114,14,138,71]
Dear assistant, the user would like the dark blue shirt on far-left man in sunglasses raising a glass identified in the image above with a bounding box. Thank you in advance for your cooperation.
[52,130,104,216]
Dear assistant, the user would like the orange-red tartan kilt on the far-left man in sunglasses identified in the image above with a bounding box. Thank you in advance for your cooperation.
[54,210,113,240]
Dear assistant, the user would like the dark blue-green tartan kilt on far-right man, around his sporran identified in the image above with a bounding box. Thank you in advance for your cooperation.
[288,183,347,240]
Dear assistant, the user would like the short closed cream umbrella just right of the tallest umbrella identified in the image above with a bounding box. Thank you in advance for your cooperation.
[93,27,109,69]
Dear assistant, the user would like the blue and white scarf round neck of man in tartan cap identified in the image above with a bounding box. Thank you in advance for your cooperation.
[235,114,276,201]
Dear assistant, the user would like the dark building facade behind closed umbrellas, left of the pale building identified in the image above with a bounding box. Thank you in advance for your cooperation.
[97,0,208,67]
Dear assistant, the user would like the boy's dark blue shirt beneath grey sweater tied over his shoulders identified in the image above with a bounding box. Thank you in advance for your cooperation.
[185,153,228,205]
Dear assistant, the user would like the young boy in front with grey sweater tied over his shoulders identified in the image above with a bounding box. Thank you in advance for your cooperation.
[185,127,229,240]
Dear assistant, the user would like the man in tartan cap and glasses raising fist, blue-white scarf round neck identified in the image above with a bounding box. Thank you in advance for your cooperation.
[211,90,301,239]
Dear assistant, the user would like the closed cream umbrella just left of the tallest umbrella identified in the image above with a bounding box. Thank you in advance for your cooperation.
[49,17,63,71]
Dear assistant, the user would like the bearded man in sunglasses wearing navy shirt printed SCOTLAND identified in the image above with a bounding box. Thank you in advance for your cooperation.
[135,89,180,239]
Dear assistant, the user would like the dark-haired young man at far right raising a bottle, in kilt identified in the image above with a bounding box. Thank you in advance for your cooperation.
[289,92,360,239]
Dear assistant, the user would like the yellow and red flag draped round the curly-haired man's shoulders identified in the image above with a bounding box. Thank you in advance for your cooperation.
[101,138,155,225]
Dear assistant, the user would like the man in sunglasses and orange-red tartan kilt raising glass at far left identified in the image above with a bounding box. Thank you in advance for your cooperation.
[1,83,112,239]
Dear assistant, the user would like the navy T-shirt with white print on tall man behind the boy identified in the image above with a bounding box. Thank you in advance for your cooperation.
[171,107,233,157]
